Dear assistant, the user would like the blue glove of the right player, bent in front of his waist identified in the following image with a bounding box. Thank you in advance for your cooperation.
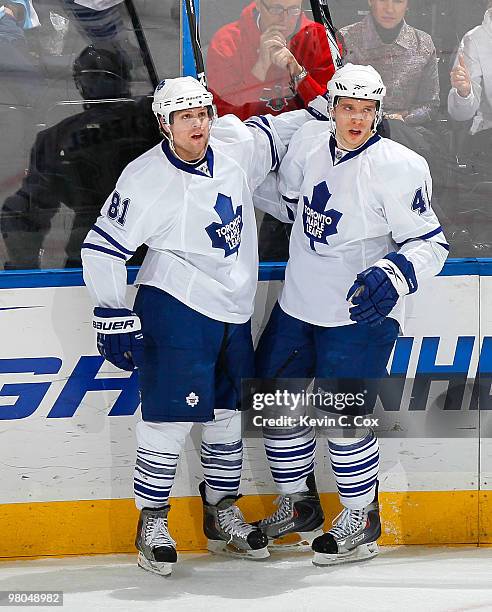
[347,253,418,325]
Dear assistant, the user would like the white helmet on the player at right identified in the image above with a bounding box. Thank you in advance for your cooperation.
[327,64,386,134]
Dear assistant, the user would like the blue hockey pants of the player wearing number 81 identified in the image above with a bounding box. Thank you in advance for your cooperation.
[134,285,254,423]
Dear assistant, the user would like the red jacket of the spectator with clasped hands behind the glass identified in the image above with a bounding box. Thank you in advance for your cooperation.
[207,2,335,119]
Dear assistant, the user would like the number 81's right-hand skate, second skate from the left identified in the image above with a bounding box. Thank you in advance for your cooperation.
[200,482,270,559]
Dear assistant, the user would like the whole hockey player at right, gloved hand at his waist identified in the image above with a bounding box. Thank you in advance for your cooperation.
[257,64,449,565]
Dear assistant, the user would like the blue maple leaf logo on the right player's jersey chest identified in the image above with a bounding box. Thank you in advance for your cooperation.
[302,181,342,251]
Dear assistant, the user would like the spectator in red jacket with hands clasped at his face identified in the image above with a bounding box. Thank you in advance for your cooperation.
[207,0,334,119]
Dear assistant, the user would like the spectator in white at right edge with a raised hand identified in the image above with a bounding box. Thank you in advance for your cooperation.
[448,2,492,173]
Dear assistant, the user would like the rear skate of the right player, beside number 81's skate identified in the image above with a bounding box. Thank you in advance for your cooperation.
[255,474,325,550]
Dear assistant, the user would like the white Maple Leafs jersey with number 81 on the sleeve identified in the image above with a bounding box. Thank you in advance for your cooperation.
[82,110,312,323]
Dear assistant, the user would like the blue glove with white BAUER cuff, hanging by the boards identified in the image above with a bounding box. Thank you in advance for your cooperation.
[92,307,143,371]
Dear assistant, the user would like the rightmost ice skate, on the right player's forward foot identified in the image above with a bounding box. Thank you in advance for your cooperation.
[312,493,381,565]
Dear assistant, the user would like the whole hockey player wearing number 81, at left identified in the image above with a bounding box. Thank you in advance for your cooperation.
[82,77,326,574]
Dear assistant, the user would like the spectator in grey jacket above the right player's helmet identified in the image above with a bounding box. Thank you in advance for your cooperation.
[340,0,439,125]
